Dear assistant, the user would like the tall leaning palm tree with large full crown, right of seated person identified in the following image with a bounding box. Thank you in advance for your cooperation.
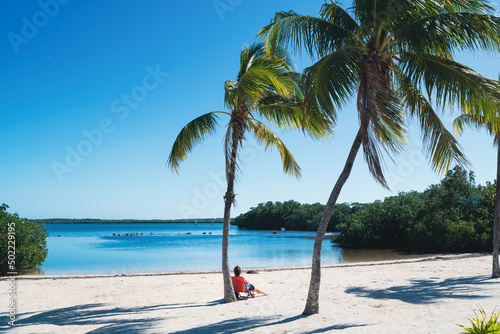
[259,0,500,314]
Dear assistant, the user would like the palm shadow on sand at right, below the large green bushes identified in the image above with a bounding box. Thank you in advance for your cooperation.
[345,276,500,304]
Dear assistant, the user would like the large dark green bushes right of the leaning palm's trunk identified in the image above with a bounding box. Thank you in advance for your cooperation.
[334,167,495,253]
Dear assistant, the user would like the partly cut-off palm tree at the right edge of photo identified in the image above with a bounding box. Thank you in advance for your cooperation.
[454,108,500,278]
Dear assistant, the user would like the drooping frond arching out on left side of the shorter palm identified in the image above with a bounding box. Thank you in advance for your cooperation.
[167,112,218,173]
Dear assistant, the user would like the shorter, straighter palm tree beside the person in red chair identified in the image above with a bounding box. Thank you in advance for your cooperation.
[167,43,322,302]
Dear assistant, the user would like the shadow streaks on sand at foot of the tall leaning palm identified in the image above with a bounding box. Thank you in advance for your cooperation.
[171,315,366,334]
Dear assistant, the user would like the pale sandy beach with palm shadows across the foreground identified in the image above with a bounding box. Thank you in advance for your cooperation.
[0,256,500,334]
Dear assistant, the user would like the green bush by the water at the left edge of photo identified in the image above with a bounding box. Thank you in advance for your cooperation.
[0,203,48,276]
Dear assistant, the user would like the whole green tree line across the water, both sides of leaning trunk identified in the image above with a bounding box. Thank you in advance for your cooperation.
[232,167,496,253]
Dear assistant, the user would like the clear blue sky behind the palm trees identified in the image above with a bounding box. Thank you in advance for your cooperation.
[0,0,500,219]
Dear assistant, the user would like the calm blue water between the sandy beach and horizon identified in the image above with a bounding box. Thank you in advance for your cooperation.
[41,223,343,275]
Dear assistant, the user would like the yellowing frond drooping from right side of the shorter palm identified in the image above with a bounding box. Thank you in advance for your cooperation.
[248,119,301,178]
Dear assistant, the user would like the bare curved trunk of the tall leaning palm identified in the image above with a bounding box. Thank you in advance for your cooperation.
[302,130,361,315]
